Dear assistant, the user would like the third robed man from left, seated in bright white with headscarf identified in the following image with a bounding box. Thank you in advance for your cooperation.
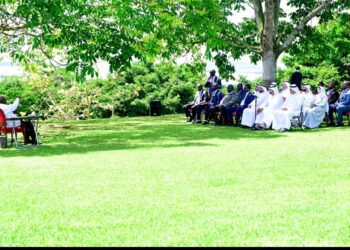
[272,84,304,132]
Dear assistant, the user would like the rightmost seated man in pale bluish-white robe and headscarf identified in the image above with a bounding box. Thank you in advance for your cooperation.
[303,86,328,128]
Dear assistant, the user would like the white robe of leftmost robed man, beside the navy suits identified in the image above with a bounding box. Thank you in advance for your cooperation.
[241,88,269,127]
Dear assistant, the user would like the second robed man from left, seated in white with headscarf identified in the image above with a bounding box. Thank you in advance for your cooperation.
[255,83,283,130]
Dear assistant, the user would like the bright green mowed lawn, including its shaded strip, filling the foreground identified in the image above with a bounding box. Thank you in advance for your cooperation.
[0,115,350,246]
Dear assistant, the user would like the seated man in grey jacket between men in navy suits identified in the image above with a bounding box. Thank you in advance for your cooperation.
[210,84,239,125]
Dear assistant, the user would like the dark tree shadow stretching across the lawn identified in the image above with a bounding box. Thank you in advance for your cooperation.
[0,115,348,157]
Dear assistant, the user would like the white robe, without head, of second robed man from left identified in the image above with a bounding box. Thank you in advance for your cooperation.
[255,94,283,128]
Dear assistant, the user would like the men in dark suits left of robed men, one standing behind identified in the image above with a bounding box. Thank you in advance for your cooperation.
[183,70,254,125]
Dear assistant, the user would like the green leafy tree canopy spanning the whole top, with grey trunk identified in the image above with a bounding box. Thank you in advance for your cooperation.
[0,0,350,82]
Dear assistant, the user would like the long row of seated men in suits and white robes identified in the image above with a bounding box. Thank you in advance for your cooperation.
[184,81,350,131]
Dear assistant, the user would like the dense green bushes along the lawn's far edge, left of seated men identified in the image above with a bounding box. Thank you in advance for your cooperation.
[0,62,205,120]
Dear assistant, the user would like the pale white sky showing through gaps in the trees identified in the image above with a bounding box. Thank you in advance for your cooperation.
[0,0,306,83]
